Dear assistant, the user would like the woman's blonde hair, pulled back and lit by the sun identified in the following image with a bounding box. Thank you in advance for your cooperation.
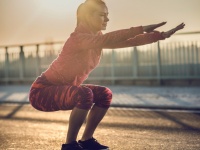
[77,0,107,25]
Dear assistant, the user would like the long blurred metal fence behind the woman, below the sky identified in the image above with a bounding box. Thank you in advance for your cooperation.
[0,32,200,84]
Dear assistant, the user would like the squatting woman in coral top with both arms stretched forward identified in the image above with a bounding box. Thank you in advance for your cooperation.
[29,0,184,150]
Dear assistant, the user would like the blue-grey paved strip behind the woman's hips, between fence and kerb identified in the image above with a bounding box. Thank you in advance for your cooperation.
[0,85,200,110]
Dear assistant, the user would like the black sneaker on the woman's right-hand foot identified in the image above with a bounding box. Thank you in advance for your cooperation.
[78,138,109,150]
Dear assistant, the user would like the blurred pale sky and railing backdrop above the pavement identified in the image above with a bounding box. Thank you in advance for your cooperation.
[0,0,200,85]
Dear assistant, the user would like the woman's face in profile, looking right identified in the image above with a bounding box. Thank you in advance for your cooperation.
[88,5,109,33]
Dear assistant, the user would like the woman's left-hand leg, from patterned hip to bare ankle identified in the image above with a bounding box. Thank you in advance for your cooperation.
[29,76,93,143]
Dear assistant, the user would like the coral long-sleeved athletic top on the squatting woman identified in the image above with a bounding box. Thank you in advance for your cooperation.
[44,24,164,86]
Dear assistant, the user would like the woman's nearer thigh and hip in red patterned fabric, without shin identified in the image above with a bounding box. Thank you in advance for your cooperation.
[29,76,93,112]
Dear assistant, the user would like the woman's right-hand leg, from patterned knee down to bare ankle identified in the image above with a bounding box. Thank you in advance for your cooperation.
[81,85,112,141]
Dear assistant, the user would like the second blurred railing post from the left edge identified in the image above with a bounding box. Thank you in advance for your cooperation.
[19,46,25,81]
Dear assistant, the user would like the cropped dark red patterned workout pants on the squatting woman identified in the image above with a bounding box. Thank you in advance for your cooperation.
[29,75,112,111]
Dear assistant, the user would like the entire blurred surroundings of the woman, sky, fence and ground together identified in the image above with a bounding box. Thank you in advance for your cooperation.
[0,0,200,150]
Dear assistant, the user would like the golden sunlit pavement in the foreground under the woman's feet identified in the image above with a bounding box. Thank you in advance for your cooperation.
[0,104,200,150]
